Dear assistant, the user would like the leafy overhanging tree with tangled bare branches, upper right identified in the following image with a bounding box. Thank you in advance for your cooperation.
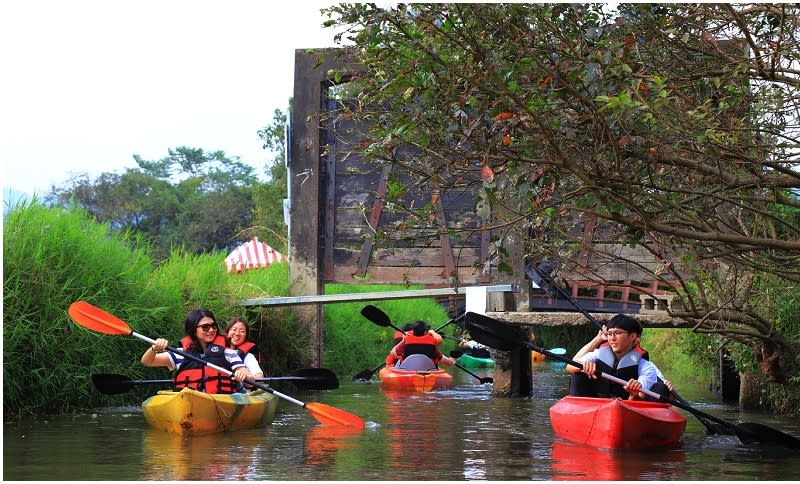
[328,3,800,390]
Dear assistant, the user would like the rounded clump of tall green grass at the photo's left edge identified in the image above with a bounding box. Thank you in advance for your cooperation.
[3,200,157,416]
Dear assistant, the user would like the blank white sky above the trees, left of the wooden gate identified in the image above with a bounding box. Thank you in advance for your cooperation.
[0,0,335,198]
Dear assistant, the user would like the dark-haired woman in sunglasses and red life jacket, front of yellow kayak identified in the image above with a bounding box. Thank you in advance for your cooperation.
[142,308,249,393]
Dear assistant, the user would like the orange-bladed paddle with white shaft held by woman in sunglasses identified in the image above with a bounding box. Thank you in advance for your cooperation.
[67,301,365,428]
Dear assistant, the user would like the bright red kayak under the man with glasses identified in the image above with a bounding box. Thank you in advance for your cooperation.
[550,396,686,449]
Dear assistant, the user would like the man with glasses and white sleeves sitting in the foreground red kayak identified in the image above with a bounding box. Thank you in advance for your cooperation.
[567,314,669,400]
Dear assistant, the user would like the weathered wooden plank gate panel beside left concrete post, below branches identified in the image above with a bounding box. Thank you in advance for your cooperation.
[324,100,491,286]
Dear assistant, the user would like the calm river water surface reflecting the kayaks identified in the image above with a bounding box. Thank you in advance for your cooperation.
[3,363,800,481]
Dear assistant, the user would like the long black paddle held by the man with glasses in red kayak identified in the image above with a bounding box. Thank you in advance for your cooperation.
[466,312,800,449]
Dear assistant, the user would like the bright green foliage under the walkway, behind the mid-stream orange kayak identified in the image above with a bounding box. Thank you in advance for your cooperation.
[323,284,453,376]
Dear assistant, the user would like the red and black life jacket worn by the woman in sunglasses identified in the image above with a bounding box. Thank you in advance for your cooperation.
[174,335,236,393]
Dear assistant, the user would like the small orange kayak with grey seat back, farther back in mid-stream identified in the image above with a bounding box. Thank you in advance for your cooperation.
[378,355,453,392]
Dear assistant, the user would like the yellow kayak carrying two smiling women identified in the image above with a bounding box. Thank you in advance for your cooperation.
[142,388,278,435]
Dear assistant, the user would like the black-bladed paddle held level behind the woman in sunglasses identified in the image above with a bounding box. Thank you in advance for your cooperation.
[92,368,339,395]
